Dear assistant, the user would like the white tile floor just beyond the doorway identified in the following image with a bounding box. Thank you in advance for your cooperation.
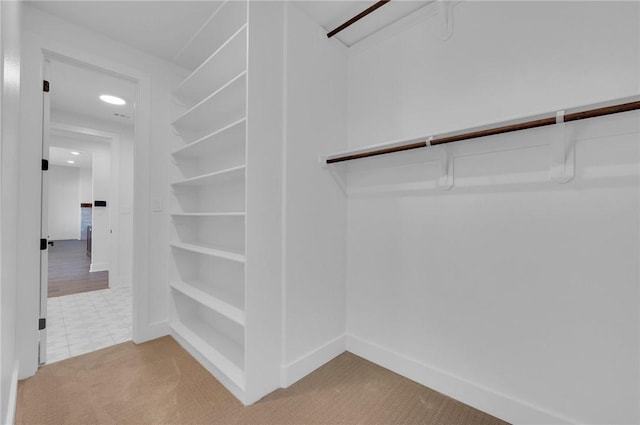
[47,284,132,363]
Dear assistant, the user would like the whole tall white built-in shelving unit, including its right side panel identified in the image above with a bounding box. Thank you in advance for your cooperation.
[169,0,283,404]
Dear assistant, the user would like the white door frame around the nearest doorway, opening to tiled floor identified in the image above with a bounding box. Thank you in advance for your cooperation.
[16,32,158,379]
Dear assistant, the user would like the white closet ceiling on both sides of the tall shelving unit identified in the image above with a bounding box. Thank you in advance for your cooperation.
[27,0,431,54]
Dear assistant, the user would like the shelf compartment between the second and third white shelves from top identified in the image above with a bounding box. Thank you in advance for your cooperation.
[172,71,247,143]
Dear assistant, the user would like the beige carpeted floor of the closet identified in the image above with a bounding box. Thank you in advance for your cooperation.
[16,337,505,425]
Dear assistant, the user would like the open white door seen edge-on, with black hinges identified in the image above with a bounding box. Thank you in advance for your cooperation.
[38,59,51,364]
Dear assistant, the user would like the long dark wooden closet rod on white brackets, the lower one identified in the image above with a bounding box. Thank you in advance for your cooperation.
[327,101,640,164]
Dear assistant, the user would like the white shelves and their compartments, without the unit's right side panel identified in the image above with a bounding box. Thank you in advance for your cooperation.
[170,1,248,401]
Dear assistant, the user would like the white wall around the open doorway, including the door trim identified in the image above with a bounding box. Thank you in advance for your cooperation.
[17,6,178,377]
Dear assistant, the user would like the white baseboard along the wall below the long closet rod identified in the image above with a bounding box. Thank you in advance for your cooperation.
[346,335,579,425]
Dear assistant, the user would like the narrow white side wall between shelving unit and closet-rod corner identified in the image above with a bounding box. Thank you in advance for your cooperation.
[282,5,347,386]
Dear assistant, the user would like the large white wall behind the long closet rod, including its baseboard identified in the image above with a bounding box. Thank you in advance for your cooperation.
[347,2,640,424]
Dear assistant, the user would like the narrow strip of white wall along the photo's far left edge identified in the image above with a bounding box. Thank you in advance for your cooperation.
[0,2,20,424]
